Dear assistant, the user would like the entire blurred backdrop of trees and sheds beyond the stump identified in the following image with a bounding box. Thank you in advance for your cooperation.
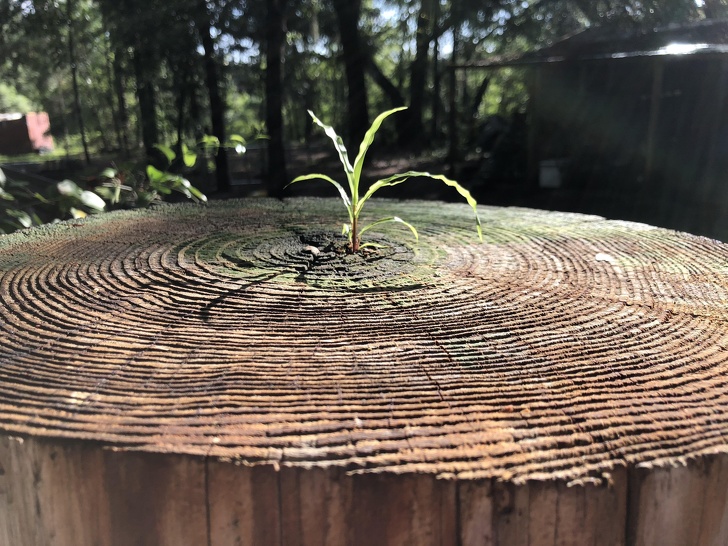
[0,0,728,240]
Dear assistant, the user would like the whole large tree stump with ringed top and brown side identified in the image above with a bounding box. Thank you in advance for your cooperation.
[0,199,728,546]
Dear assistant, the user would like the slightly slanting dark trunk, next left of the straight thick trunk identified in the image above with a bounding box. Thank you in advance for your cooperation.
[198,0,230,193]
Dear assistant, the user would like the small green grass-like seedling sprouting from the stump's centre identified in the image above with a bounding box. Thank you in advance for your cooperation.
[289,106,483,252]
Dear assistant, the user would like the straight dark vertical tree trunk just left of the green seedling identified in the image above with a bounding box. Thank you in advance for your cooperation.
[265,0,289,197]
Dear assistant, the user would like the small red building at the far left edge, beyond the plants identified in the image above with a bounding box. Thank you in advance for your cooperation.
[0,112,53,155]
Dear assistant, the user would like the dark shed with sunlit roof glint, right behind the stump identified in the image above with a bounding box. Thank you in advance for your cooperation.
[456,20,728,240]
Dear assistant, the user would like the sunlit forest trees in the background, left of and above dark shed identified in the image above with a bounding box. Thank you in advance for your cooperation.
[0,0,728,200]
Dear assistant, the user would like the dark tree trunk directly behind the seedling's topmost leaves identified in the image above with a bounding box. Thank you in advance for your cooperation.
[333,0,369,150]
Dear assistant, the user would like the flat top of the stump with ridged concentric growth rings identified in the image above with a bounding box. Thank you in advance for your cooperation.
[0,199,728,544]
